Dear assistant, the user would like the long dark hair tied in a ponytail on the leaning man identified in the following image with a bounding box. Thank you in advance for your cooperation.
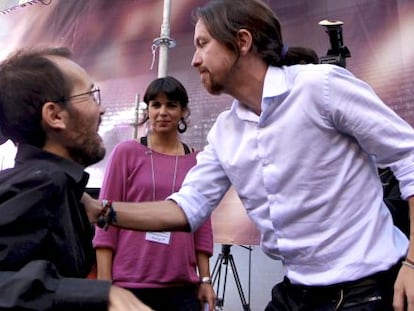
[193,0,318,67]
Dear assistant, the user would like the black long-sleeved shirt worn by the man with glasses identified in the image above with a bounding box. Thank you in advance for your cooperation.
[0,145,110,310]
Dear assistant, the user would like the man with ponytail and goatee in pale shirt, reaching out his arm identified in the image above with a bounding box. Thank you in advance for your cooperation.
[85,0,414,311]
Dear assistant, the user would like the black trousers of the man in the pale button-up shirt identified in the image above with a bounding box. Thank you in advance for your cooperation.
[265,261,401,311]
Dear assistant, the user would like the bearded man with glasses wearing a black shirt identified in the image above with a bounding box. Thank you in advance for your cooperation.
[0,48,150,311]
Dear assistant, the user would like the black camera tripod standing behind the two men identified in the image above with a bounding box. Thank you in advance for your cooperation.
[212,244,252,311]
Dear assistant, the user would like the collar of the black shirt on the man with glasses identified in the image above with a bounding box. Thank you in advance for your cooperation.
[15,144,89,186]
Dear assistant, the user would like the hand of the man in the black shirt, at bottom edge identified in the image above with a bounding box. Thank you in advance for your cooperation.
[108,286,153,311]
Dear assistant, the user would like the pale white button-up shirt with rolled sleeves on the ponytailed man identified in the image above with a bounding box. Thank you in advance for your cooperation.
[170,64,414,285]
